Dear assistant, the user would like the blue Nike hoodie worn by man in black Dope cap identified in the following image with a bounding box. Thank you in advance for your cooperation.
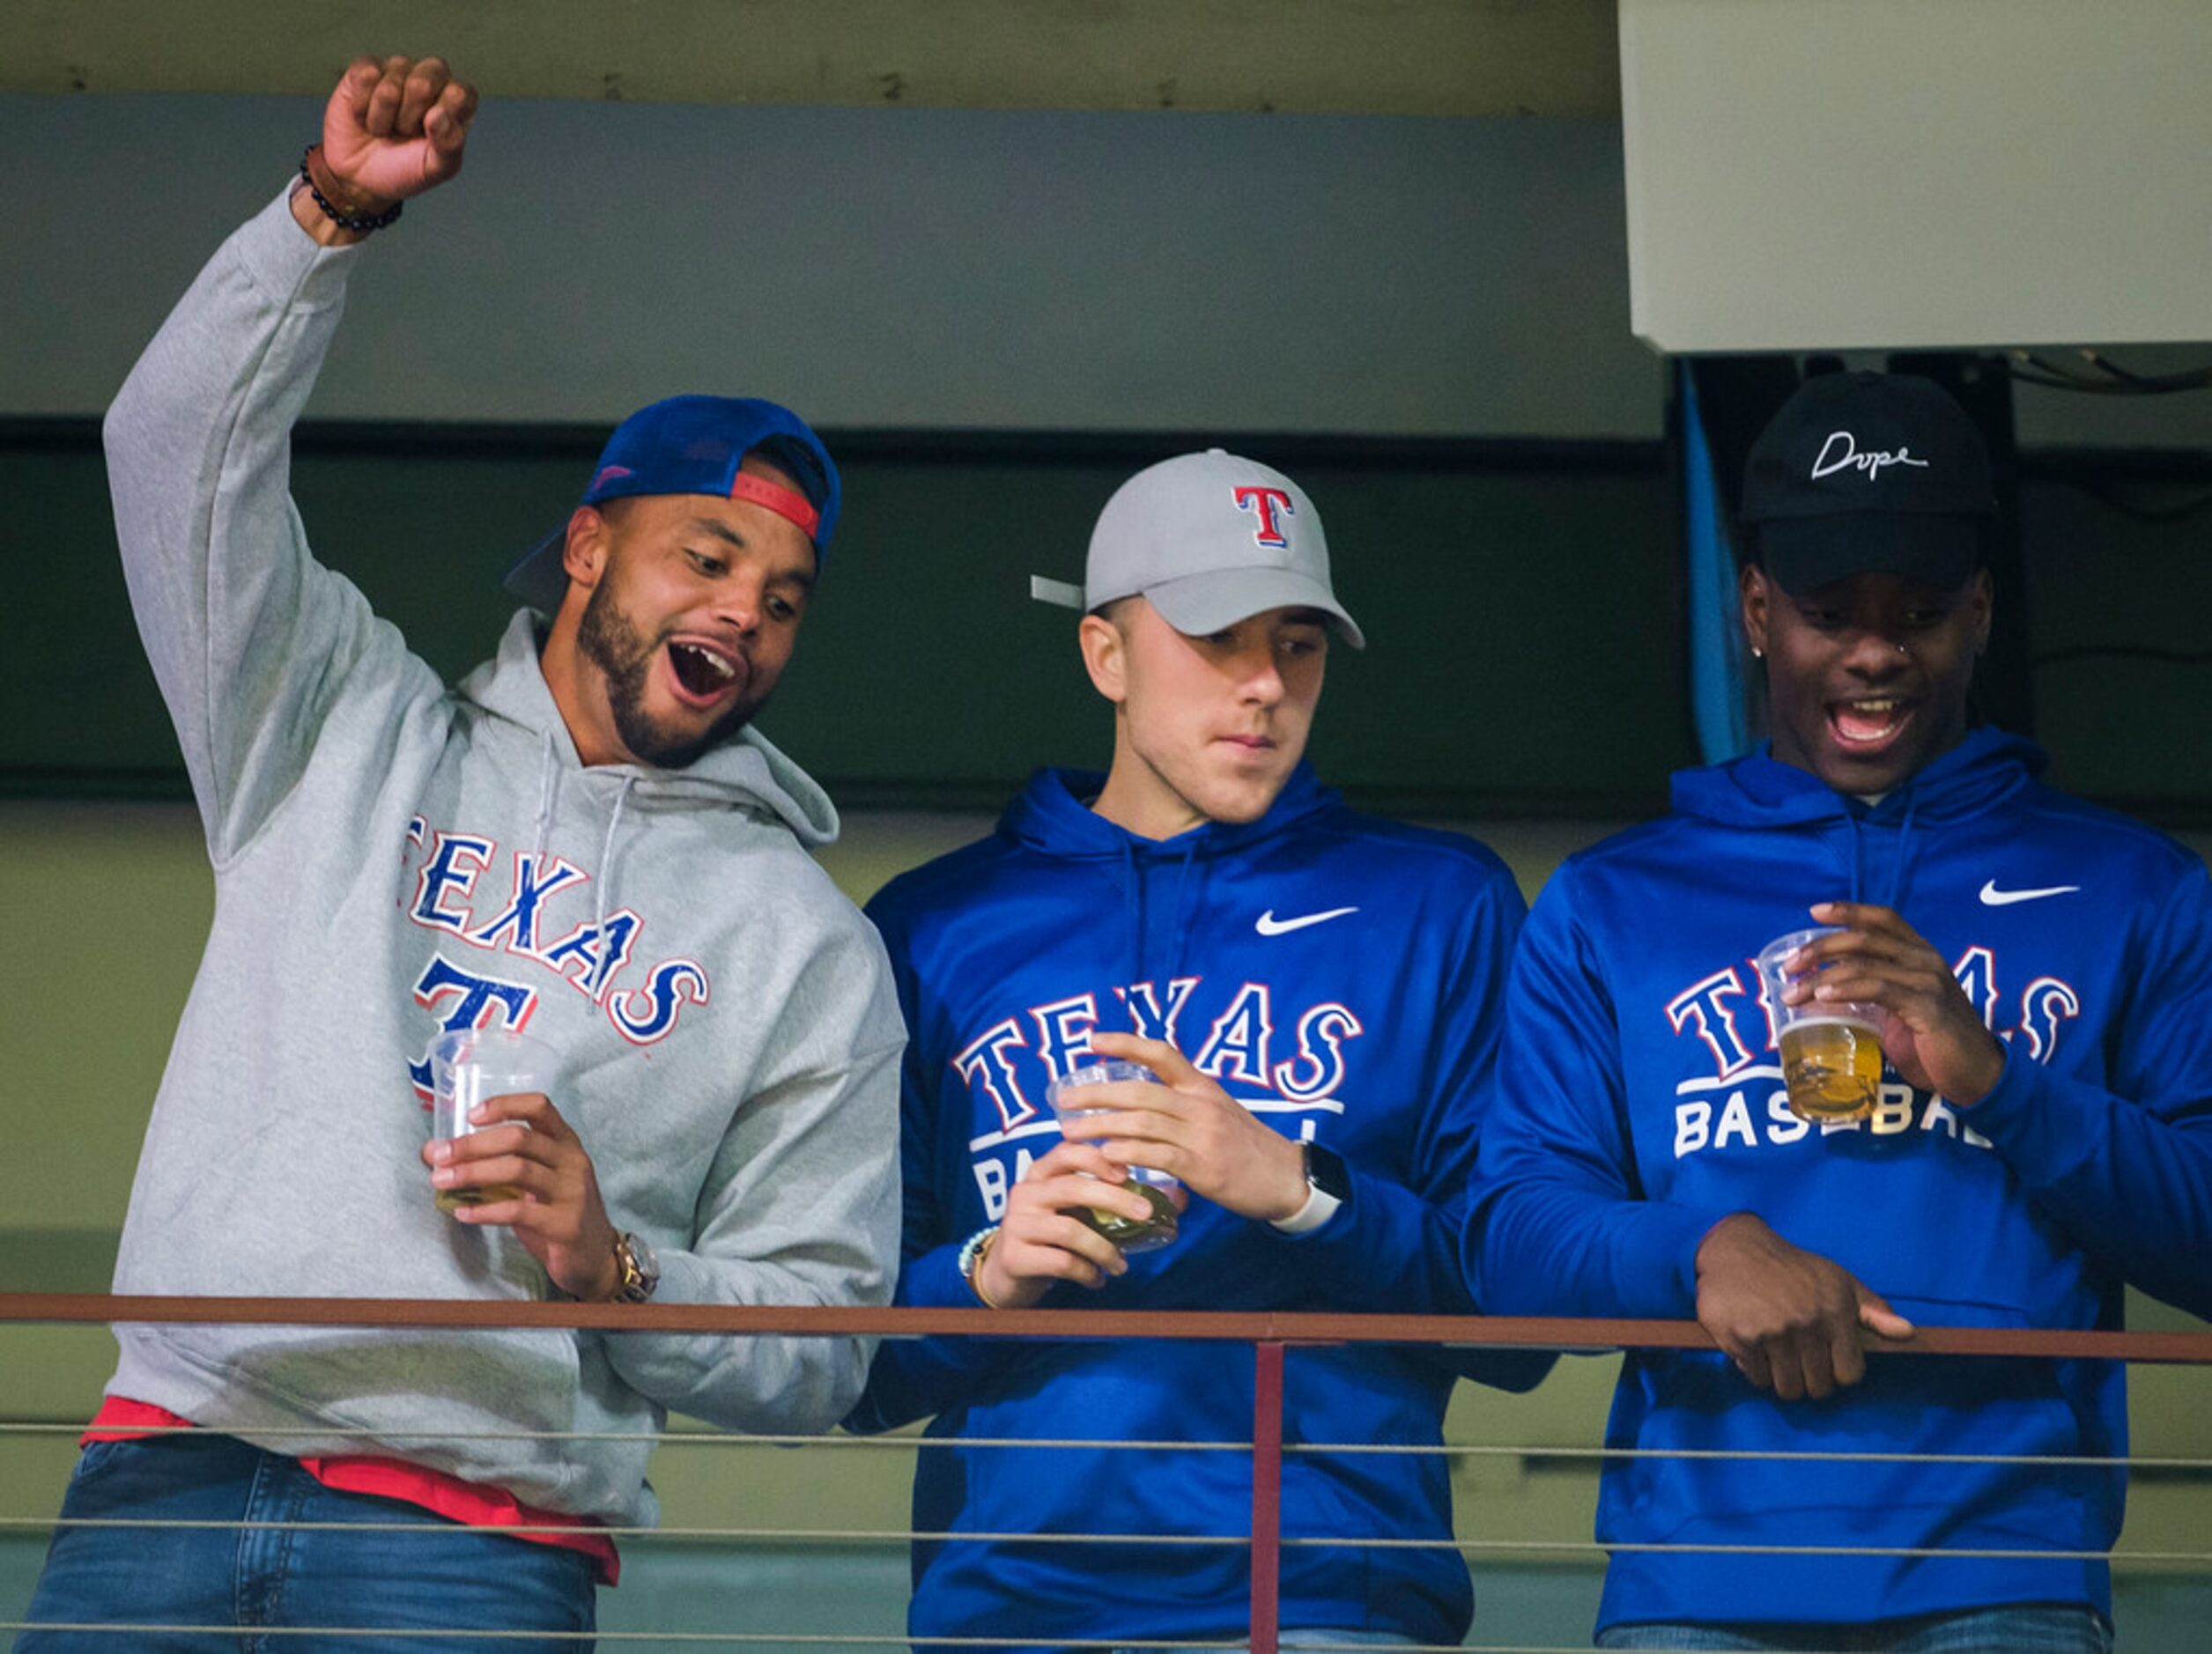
[1467,730,2212,1625]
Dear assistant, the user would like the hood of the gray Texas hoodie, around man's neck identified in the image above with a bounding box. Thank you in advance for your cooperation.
[455,610,839,849]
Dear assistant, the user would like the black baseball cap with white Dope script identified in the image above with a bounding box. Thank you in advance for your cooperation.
[1741,372,1997,593]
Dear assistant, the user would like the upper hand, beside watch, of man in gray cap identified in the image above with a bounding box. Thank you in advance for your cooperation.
[1079,1032,1307,1221]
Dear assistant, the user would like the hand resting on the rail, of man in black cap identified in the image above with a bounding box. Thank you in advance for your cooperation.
[1697,1212,1913,1402]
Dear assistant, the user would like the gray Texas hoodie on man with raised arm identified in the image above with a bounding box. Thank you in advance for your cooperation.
[107,196,902,1524]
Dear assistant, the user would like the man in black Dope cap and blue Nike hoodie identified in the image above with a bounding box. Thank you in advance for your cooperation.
[1467,373,2212,1654]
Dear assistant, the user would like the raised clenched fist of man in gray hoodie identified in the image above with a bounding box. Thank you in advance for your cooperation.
[292,57,476,246]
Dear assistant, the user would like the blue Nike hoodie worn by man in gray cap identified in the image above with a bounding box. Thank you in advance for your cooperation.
[847,765,1550,1647]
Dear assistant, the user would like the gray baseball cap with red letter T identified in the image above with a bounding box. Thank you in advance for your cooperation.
[1029,449,1367,648]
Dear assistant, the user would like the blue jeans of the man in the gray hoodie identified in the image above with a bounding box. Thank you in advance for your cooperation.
[16,1430,597,1654]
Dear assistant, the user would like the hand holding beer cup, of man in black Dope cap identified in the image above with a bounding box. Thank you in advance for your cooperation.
[1783,902,2004,1108]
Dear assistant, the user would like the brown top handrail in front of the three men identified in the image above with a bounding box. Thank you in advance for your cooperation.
[0,1291,2212,1367]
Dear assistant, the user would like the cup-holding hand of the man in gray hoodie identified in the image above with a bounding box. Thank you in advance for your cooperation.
[423,1092,622,1303]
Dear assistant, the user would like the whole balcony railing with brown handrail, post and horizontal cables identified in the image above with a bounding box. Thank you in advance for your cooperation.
[0,1291,2212,1654]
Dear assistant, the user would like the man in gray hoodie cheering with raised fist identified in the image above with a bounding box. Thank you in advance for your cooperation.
[20,57,902,1650]
